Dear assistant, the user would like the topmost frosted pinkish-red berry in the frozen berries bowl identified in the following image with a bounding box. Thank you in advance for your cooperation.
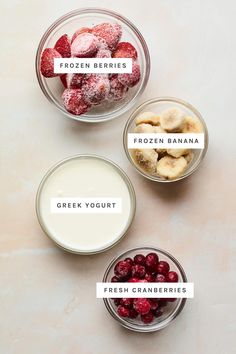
[92,22,122,50]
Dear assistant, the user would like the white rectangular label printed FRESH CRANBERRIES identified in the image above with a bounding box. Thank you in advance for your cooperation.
[96,283,194,299]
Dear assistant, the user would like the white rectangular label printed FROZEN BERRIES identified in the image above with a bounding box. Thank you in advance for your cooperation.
[54,58,132,74]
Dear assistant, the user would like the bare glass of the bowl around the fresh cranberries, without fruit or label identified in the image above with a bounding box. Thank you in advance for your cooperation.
[103,247,187,332]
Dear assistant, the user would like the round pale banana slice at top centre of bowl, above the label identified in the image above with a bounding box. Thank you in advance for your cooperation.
[160,107,185,132]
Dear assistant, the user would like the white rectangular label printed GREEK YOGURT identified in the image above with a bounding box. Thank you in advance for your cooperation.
[50,198,122,214]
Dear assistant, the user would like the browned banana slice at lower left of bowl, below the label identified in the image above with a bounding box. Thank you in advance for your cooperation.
[135,149,158,174]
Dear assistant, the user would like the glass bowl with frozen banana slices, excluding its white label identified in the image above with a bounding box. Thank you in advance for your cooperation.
[123,97,208,182]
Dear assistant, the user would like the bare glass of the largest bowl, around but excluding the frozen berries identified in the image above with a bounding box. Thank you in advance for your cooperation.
[35,8,150,123]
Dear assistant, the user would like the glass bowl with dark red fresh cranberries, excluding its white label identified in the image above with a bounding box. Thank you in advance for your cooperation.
[103,247,187,332]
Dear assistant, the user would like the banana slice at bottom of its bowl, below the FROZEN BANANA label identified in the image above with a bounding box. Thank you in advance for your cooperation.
[156,156,187,180]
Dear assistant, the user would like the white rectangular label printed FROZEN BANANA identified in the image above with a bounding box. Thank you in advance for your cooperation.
[128,133,204,149]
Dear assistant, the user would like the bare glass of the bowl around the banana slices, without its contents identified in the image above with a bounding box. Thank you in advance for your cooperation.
[123,97,208,183]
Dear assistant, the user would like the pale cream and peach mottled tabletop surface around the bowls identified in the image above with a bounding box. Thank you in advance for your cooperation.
[0,0,236,354]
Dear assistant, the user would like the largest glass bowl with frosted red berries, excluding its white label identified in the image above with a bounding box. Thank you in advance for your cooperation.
[36,8,150,123]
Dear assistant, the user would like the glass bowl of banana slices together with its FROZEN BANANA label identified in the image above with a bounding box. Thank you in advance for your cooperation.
[123,97,208,182]
